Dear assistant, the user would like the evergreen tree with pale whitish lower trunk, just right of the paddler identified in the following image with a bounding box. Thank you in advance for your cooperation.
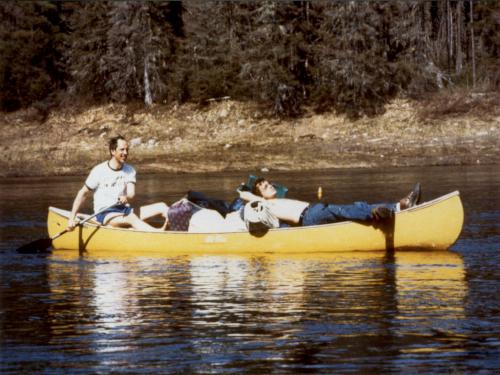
[105,1,177,105]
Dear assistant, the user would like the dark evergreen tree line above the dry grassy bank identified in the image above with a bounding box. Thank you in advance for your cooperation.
[0,0,500,116]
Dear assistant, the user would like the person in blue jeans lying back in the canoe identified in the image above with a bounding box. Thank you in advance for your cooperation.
[239,178,421,226]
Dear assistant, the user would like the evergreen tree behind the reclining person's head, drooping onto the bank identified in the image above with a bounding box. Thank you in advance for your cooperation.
[236,1,315,115]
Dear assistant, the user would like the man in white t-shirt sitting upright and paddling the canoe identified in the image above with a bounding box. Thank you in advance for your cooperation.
[68,136,161,231]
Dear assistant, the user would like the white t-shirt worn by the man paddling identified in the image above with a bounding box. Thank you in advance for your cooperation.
[85,161,136,212]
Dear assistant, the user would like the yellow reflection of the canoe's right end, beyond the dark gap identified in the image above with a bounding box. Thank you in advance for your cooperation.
[395,252,467,361]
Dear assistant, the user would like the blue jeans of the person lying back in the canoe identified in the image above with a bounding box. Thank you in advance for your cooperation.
[302,202,396,226]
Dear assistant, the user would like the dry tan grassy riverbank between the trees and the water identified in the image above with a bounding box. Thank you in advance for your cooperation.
[0,96,500,176]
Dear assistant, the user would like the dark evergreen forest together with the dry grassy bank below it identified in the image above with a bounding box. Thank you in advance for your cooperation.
[0,0,500,175]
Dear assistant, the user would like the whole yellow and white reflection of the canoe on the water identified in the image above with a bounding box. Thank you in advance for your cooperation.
[49,250,466,364]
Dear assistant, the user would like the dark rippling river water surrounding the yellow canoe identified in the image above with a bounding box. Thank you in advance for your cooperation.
[0,166,500,374]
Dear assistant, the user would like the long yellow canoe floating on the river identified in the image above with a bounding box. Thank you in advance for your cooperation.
[47,191,464,255]
